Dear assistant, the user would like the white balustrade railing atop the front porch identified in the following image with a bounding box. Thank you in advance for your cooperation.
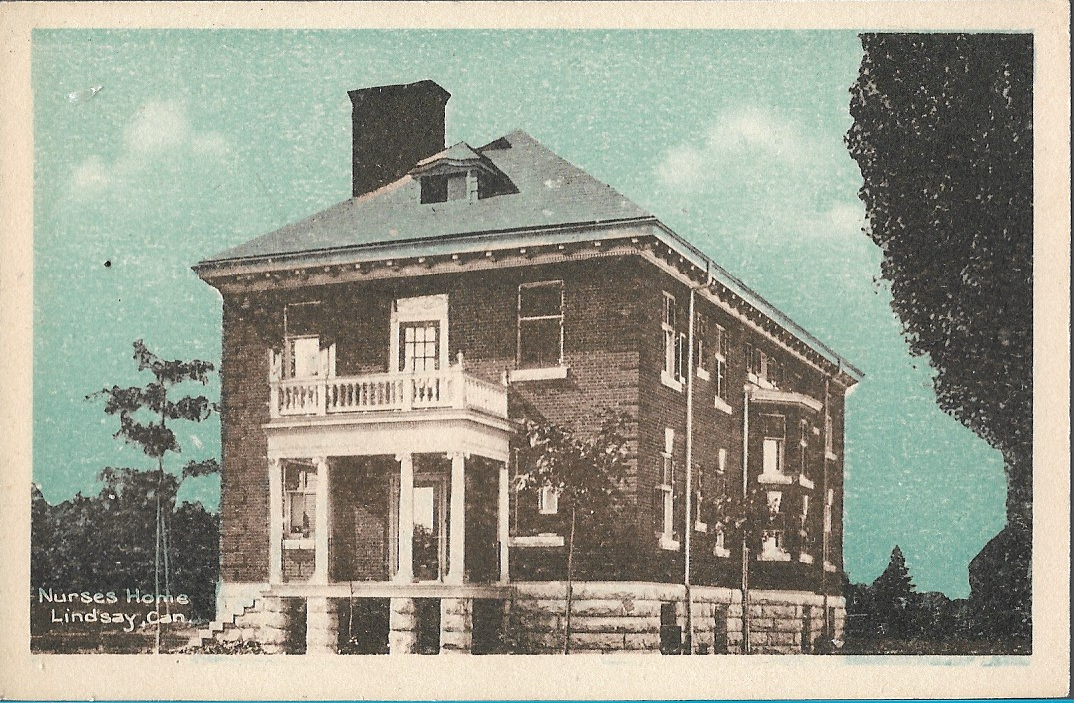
[271,366,507,418]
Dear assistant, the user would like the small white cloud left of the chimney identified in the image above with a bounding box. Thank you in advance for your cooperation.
[71,100,231,197]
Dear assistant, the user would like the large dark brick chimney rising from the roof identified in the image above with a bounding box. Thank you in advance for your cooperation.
[347,80,451,197]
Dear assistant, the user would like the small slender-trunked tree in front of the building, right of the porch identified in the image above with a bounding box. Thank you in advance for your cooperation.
[514,410,632,654]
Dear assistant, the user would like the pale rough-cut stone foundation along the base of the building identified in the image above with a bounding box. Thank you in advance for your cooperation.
[199,582,846,655]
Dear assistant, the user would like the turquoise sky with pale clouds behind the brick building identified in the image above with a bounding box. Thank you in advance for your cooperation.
[32,30,1005,598]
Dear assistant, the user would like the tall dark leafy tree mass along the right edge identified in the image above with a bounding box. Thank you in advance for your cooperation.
[846,34,1033,648]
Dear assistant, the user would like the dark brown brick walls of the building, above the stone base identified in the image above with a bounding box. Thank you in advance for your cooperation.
[215,257,843,587]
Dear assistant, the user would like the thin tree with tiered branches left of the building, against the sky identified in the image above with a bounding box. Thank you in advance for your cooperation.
[86,339,219,653]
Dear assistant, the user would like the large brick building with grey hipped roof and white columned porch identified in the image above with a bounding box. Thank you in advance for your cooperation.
[195,80,860,653]
